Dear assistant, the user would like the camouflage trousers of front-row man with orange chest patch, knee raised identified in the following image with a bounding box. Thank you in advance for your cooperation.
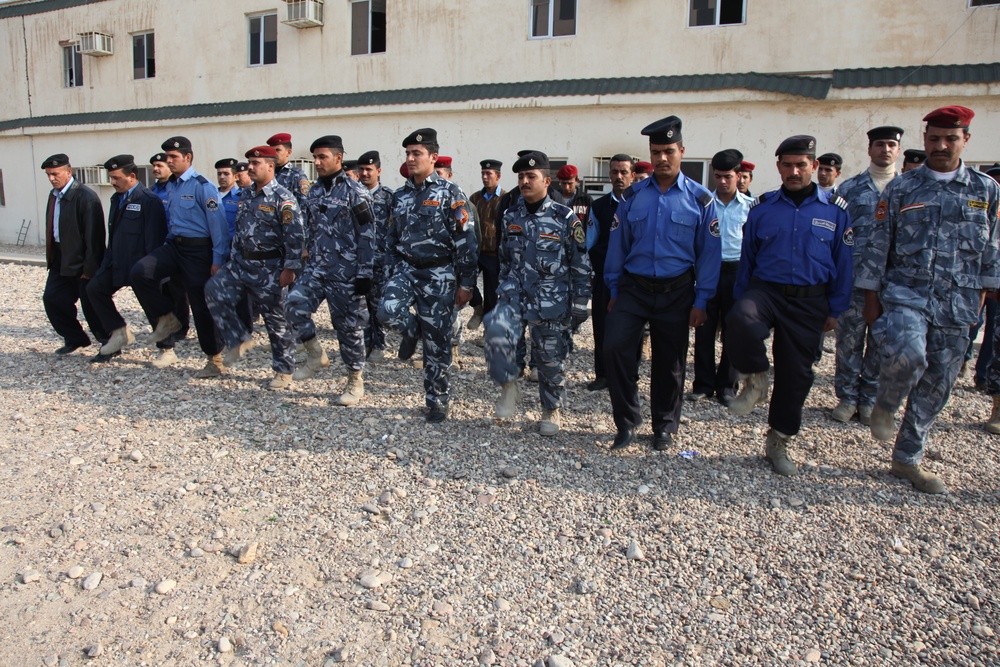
[378,266,456,408]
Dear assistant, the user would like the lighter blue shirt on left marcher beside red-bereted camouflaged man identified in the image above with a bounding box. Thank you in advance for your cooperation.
[167,167,230,266]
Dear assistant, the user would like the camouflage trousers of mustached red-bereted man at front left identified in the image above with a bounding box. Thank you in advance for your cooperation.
[205,258,295,374]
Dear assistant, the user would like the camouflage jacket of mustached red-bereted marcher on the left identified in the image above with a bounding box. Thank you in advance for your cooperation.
[232,180,303,273]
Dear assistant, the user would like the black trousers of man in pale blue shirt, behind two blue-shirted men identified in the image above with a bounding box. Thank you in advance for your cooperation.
[693,262,739,398]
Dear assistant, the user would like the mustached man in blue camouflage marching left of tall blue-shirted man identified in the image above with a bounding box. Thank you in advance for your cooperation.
[484,152,590,436]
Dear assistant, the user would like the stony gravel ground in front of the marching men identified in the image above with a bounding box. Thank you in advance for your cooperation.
[0,265,1000,667]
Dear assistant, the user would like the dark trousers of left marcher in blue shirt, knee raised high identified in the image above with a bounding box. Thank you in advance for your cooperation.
[129,241,223,355]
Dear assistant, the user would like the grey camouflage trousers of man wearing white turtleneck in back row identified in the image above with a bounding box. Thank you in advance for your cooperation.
[833,288,879,407]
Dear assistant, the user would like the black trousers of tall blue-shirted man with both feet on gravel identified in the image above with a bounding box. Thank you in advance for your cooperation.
[604,275,694,433]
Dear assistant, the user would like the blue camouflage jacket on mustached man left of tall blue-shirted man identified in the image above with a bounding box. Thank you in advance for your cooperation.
[498,197,590,321]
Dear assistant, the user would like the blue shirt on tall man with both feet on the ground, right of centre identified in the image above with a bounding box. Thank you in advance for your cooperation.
[604,173,722,310]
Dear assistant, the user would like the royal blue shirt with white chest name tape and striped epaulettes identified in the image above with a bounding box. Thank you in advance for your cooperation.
[733,187,854,317]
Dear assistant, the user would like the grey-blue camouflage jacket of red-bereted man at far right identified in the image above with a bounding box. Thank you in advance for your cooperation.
[854,162,1000,328]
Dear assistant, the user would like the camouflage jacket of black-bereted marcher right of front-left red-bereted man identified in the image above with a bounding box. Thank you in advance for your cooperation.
[306,171,375,283]
